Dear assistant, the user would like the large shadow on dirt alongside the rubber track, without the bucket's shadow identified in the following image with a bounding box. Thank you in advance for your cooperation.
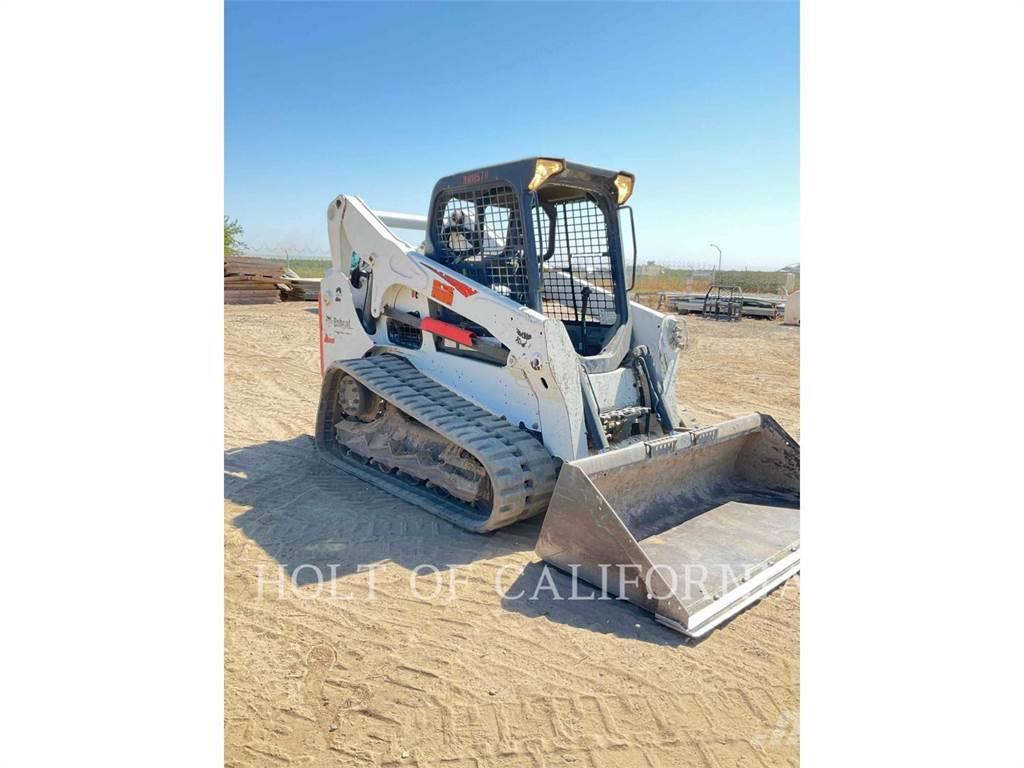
[224,434,540,586]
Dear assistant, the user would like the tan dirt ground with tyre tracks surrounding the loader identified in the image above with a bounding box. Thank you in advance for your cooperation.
[224,303,800,768]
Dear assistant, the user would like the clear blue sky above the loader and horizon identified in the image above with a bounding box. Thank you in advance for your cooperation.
[224,2,800,268]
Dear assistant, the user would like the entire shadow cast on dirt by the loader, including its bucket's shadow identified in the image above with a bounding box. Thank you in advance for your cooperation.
[224,434,696,646]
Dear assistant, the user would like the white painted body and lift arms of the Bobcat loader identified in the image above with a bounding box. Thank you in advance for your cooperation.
[321,195,684,461]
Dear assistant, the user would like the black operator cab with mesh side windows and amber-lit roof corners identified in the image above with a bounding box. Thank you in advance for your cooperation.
[427,158,636,356]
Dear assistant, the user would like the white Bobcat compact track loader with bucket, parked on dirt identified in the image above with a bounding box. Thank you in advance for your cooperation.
[316,158,800,636]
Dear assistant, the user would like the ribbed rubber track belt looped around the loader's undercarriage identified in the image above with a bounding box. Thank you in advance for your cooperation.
[316,354,557,532]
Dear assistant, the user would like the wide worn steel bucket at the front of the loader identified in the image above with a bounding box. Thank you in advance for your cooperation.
[537,414,800,637]
